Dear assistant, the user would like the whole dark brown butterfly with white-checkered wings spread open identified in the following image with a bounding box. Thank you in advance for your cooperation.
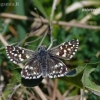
[6,39,79,79]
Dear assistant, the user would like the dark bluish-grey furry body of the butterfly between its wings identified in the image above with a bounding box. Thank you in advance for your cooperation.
[36,46,49,77]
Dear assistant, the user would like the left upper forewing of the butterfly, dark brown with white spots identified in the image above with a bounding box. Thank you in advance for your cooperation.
[6,46,34,64]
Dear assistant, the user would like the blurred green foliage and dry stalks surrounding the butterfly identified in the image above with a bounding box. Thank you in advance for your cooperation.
[0,0,100,100]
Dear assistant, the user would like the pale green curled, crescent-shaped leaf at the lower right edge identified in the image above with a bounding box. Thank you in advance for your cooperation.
[82,66,100,94]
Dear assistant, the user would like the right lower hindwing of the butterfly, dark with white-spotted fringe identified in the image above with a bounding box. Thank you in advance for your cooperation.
[48,57,68,78]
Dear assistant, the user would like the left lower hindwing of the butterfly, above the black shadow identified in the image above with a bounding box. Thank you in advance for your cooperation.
[21,58,41,79]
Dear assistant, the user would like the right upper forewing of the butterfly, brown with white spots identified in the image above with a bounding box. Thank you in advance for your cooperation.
[50,40,79,60]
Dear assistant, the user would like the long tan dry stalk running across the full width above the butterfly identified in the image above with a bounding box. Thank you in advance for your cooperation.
[0,13,100,30]
